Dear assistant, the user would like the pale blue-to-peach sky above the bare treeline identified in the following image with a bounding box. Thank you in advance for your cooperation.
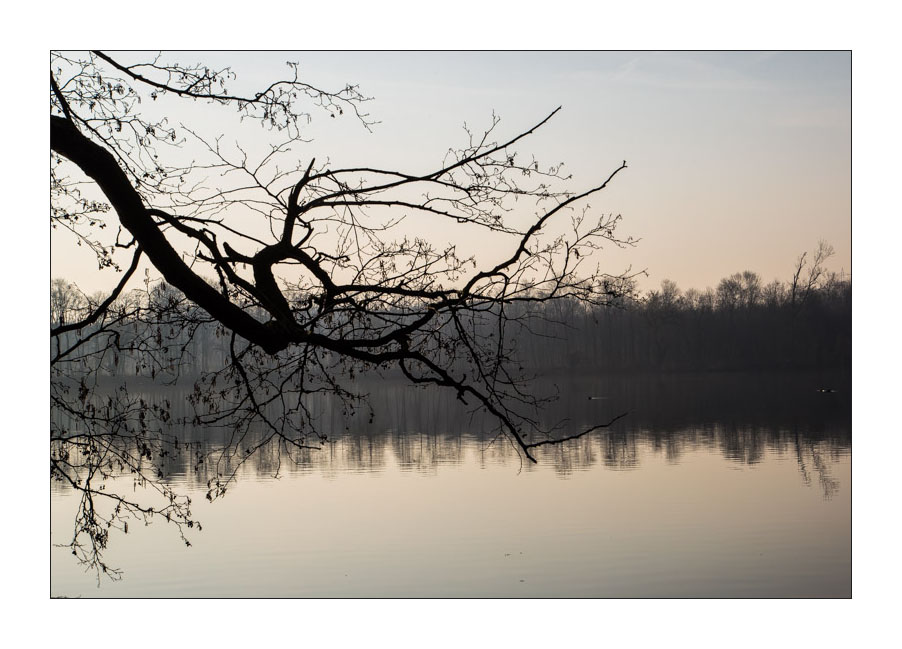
[51,51,852,293]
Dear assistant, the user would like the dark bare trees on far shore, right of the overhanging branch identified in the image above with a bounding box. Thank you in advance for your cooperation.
[518,271,852,371]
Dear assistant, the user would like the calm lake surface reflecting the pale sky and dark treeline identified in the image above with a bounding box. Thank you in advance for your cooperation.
[50,375,852,597]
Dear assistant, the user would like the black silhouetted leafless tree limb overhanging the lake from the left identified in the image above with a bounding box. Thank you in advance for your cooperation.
[50,52,634,570]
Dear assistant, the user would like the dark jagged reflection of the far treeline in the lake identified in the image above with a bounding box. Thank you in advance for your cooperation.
[51,375,851,497]
